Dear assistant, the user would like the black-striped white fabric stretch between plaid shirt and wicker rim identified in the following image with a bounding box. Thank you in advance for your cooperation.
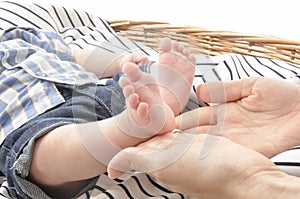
[0,1,156,56]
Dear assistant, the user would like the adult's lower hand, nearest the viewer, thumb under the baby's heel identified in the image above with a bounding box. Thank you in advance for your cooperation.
[108,133,292,199]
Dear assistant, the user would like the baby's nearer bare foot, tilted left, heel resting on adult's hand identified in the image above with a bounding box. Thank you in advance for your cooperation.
[119,63,175,138]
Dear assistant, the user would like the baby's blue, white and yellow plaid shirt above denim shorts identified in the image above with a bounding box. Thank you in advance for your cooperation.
[0,27,98,143]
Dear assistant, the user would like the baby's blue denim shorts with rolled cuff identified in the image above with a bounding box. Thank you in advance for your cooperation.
[0,72,125,199]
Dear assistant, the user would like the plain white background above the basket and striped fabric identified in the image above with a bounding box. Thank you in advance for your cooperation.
[23,0,300,41]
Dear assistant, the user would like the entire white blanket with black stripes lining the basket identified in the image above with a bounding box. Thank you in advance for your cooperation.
[0,1,300,199]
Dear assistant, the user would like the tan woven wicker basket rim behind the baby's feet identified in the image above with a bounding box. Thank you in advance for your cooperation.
[109,20,300,64]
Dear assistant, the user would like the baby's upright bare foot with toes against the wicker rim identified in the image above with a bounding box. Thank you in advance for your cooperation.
[156,38,196,115]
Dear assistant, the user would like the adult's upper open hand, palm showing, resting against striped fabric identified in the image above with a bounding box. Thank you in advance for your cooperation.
[177,78,300,157]
